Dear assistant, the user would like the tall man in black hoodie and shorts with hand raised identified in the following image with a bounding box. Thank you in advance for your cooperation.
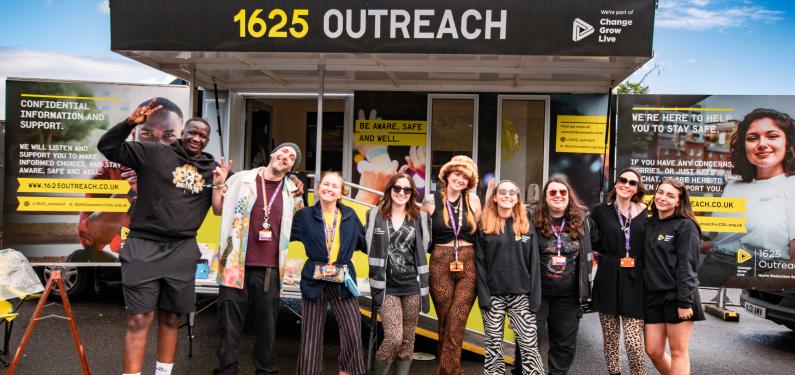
[97,101,231,375]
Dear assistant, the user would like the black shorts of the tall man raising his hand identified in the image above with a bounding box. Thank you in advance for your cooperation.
[119,238,201,314]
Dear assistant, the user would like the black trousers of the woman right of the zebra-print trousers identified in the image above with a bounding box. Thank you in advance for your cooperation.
[512,294,582,375]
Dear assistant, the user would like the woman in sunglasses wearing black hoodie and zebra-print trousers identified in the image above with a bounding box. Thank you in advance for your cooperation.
[475,180,544,375]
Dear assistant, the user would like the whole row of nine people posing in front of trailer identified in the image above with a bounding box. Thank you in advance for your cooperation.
[98,100,704,375]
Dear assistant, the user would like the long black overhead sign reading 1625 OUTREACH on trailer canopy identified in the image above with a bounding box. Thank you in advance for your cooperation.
[110,0,655,57]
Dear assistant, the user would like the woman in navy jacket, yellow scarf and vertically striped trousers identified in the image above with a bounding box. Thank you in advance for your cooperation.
[290,172,366,375]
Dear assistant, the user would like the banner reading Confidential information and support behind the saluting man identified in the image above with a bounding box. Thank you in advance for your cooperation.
[3,79,196,263]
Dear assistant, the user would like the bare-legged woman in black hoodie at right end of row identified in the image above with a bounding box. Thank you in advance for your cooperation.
[644,178,704,375]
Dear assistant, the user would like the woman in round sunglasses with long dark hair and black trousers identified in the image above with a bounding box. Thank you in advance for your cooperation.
[533,177,592,374]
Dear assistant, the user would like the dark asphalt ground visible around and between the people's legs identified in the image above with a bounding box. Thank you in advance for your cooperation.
[4,292,795,375]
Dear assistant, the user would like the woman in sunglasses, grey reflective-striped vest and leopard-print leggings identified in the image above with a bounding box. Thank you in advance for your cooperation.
[365,173,430,375]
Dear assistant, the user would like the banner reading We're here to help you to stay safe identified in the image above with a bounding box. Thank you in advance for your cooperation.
[616,95,795,290]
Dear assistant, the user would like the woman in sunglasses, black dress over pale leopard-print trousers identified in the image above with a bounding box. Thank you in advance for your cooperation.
[591,168,647,375]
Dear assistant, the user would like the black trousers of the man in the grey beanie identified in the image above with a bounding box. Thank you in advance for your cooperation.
[213,267,280,374]
